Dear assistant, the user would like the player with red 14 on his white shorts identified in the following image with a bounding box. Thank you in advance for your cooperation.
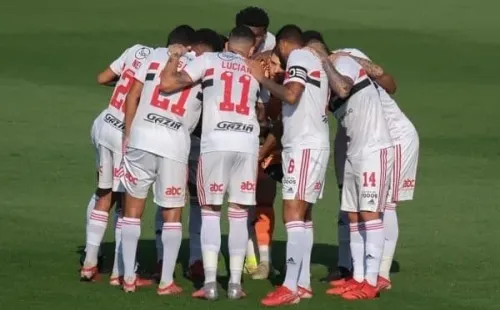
[310,42,394,300]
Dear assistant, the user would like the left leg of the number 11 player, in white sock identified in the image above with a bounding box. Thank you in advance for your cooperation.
[192,205,221,300]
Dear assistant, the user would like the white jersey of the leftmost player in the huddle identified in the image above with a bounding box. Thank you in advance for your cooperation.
[98,44,153,153]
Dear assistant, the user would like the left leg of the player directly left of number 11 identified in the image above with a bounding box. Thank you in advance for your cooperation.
[122,193,151,293]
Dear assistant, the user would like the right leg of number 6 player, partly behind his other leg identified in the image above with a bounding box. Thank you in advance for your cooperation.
[297,205,314,299]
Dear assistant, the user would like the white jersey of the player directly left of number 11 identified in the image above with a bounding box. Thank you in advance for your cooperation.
[128,48,201,163]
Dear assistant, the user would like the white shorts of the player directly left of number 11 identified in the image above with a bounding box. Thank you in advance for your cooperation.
[122,148,187,208]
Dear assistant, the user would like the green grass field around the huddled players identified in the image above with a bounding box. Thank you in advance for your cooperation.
[0,0,500,310]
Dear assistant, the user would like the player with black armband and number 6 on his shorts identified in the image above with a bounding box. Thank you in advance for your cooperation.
[245,25,330,306]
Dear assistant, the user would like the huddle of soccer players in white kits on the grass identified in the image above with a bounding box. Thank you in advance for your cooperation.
[80,7,419,306]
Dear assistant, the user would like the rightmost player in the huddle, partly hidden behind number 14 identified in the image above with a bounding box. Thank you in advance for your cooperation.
[334,48,419,290]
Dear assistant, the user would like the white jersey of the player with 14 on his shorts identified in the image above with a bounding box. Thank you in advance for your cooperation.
[333,56,392,157]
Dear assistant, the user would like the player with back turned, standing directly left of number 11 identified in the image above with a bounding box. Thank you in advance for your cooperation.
[118,25,201,295]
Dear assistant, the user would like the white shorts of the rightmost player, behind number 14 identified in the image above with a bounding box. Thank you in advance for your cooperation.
[387,135,419,202]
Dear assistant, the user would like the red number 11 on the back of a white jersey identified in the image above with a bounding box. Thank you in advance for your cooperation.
[219,71,251,115]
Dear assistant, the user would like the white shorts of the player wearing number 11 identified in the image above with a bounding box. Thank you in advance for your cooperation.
[197,152,257,206]
